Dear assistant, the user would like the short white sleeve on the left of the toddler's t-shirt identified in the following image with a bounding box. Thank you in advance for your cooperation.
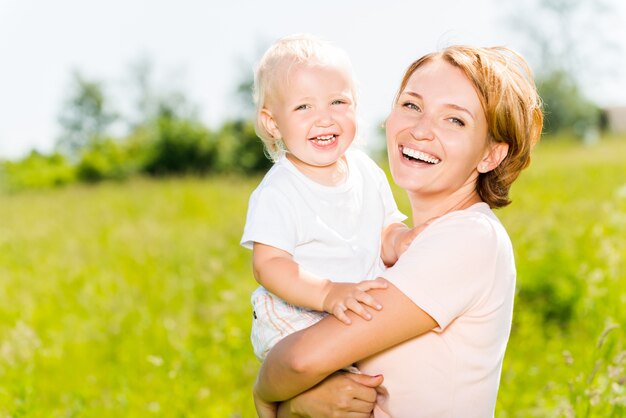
[241,187,298,254]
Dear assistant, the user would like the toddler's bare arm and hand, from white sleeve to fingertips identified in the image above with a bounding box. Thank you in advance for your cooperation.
[252,242,387,324]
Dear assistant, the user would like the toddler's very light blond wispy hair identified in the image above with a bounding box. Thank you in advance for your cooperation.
[253,34,356,162]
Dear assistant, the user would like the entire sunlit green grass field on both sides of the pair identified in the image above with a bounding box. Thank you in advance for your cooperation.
[0,140,626,418]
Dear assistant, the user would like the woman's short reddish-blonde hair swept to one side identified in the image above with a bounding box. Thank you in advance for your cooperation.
[396,45,543,208]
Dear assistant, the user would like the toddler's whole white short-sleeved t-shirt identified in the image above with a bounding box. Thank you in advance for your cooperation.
[241,149,406,282]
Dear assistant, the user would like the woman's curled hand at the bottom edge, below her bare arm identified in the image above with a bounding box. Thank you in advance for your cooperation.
[276,372,383,418]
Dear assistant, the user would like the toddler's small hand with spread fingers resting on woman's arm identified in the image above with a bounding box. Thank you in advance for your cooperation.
[323,278,387,325]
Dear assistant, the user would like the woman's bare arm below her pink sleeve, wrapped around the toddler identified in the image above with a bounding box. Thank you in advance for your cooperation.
[254,283,437,402]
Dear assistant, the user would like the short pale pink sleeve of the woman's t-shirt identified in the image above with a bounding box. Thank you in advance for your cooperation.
[382,212,498,332]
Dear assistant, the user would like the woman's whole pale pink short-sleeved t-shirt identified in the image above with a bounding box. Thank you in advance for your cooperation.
[358,203,516,418]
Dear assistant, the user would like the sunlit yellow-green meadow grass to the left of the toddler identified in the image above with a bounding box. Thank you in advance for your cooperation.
[0,178,258,418]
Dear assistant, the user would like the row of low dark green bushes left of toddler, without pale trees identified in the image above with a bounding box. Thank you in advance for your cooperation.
[0,114,272,189]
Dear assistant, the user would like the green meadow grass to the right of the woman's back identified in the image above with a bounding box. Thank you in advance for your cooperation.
[498,138,626,417]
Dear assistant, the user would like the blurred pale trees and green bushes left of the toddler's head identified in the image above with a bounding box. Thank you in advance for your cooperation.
[0,60,271,190]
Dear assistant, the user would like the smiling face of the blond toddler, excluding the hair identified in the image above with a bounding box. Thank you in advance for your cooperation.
[267,65,356,168]
